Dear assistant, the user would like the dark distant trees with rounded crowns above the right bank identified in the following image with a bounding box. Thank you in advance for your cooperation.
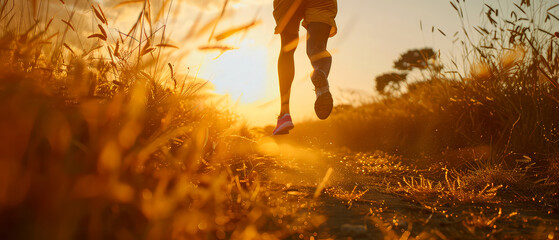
[375,48,442,95]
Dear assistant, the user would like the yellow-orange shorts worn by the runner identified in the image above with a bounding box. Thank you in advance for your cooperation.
[274,0,338,37]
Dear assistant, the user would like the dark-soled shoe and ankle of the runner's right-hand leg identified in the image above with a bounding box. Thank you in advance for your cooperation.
[311,70,334,120]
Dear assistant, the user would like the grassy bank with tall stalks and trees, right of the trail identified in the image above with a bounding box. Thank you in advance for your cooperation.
[286,1,559,215]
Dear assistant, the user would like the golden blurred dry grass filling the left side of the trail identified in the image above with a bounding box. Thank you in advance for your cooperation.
[0,0,321,239]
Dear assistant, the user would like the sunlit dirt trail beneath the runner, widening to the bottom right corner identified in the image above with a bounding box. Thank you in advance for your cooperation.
[259,138,559,239]
